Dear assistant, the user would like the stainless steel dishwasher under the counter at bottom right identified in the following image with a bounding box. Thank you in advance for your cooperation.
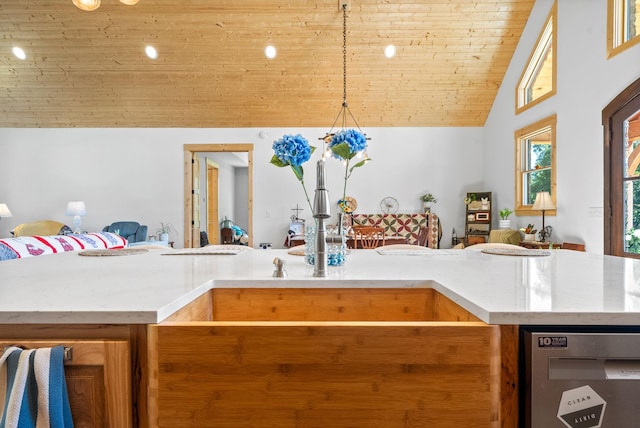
[521,328,640,428]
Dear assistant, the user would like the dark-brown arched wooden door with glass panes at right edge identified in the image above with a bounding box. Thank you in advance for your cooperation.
[602,79,640,258]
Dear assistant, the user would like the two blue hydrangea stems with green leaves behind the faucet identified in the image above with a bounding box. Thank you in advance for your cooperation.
[271,125,370,214]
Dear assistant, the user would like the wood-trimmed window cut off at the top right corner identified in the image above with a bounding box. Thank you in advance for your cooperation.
[607,0,640,58]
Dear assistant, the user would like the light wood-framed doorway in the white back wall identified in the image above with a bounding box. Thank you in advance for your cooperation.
[184,144,253,248]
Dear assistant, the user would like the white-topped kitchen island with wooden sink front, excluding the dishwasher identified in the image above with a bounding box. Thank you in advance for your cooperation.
[0,249,640,427]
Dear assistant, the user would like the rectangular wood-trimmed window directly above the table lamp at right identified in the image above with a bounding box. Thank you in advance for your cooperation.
[515,115,557,215]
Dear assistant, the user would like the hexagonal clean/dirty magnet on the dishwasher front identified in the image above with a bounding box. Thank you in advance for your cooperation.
[558,385,607,428]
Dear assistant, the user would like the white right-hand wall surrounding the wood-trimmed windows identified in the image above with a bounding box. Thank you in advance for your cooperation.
[483,0,640,253]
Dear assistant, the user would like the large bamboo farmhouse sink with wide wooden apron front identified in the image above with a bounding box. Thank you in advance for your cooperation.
[148,288,517,427]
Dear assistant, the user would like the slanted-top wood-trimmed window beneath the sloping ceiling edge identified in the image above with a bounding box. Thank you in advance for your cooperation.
[516,3,557,114]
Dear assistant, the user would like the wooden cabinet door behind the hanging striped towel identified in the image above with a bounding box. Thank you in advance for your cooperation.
[0,339,132,428]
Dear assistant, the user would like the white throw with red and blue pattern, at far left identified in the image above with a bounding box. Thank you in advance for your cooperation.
[0,232,127,260]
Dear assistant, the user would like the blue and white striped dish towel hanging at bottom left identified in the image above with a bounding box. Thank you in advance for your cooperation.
[0,346,73,428]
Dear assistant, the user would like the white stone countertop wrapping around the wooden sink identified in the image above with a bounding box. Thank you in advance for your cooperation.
[0,249,640,325]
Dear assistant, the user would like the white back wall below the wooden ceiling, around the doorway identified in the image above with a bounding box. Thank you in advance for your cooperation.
[0,126,484,247]
